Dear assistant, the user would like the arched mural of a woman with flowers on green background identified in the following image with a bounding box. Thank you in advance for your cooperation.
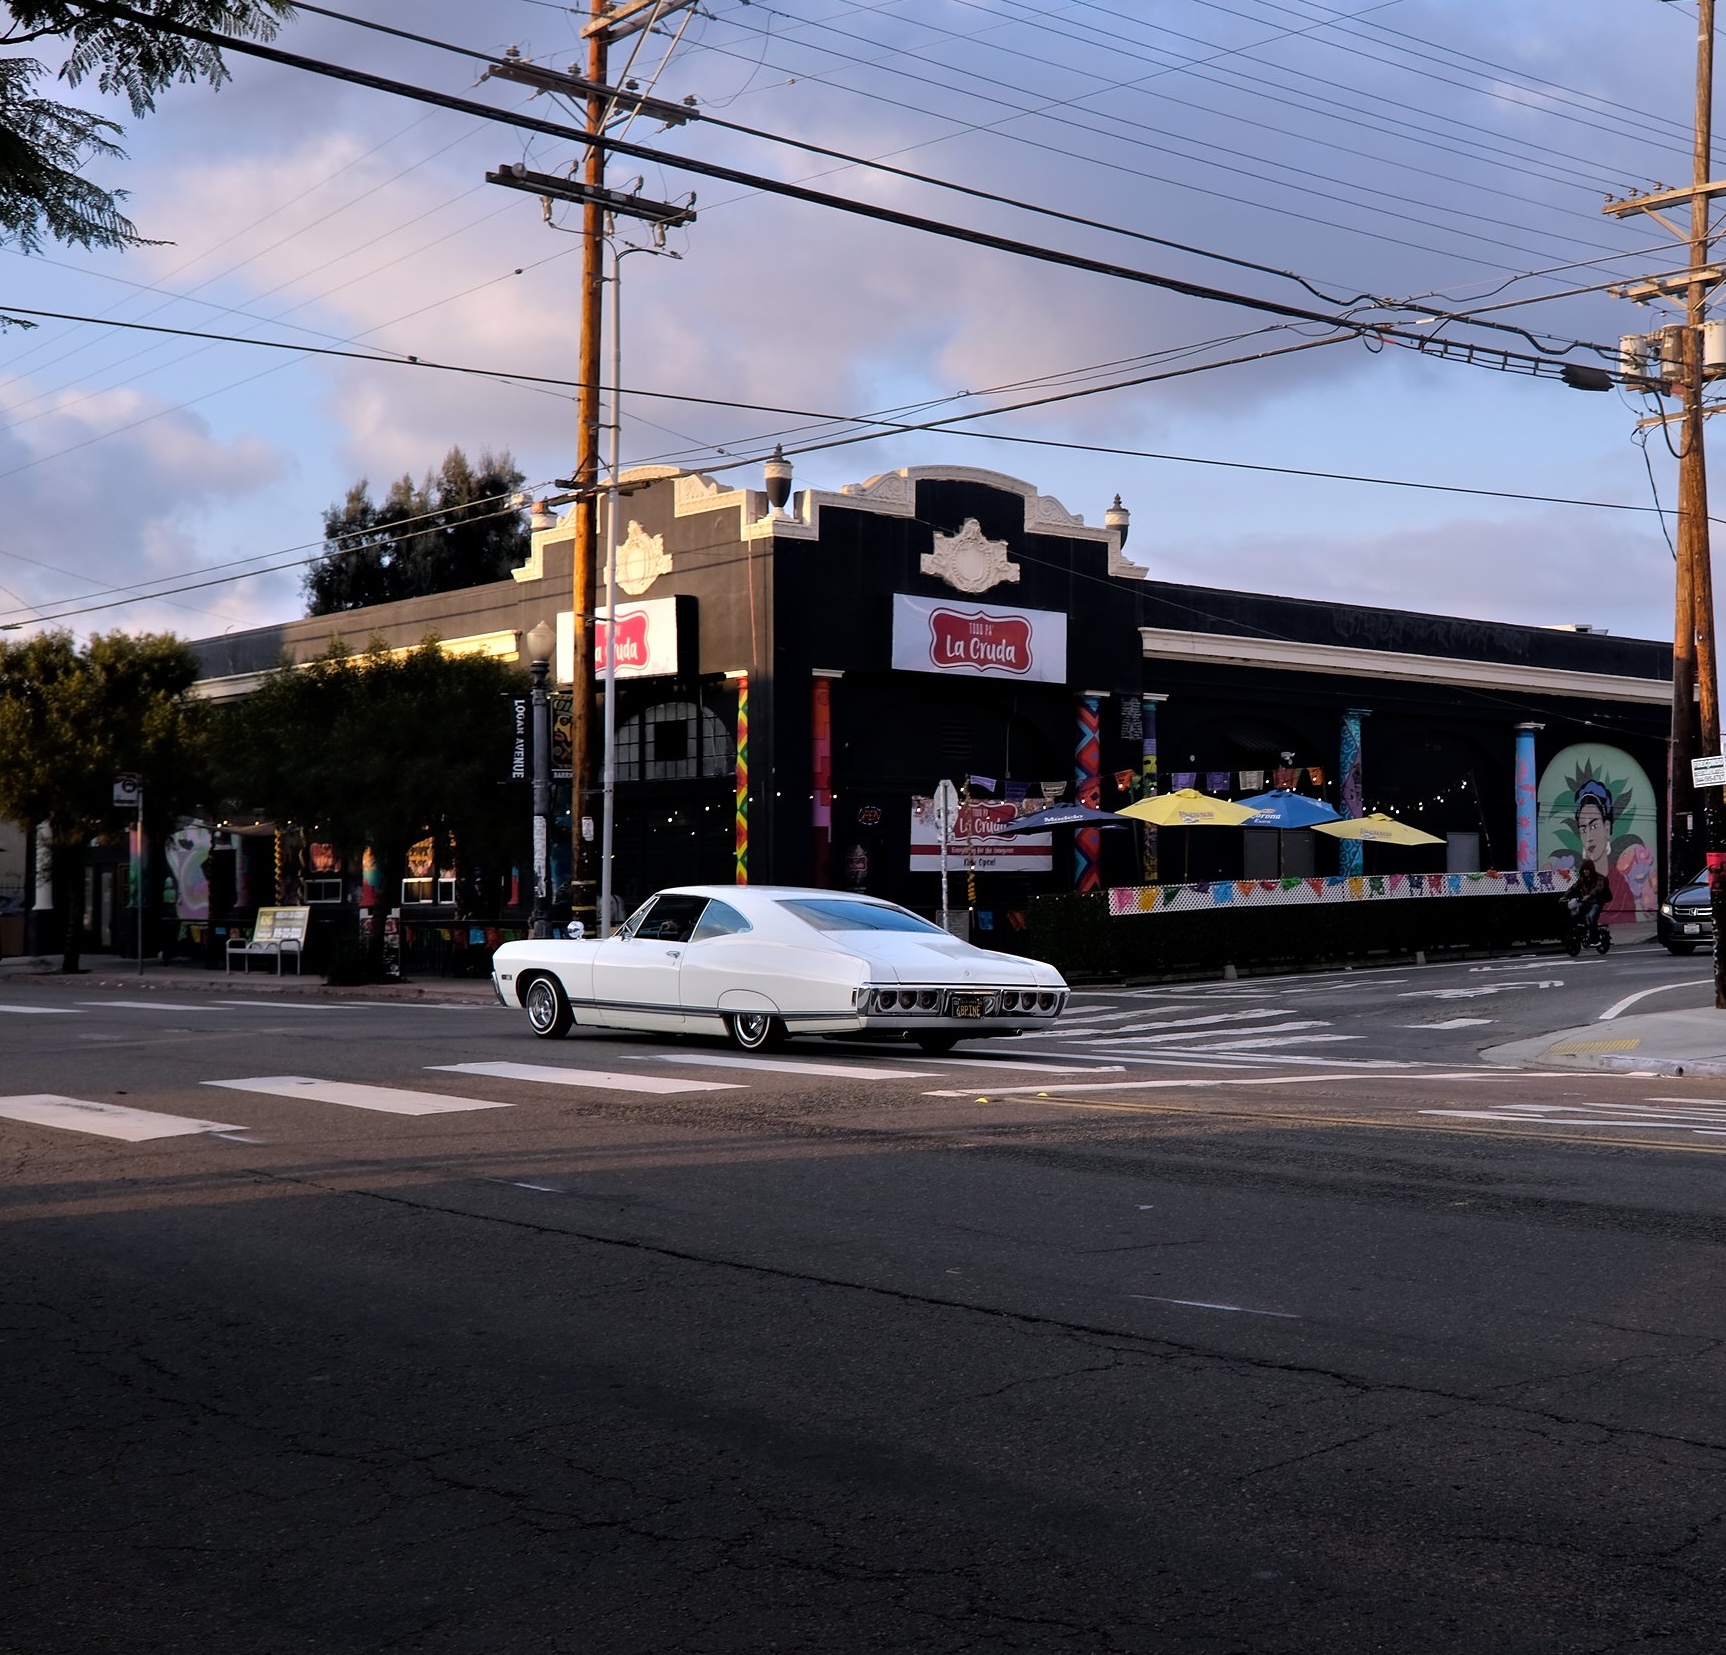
[1538,742,1660,925]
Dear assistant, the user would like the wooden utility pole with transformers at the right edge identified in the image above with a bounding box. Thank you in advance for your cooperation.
[1605,0,1726,1010]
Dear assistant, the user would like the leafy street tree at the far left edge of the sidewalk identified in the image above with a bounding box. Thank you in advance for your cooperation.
[0,632,205,972]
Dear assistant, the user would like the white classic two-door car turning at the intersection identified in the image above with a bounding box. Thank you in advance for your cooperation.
[492,885,1067,1053]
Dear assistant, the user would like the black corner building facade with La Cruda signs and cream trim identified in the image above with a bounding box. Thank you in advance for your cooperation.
[195,466,1670,927]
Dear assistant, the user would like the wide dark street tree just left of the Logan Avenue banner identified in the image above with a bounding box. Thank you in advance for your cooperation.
[216,637,528,954]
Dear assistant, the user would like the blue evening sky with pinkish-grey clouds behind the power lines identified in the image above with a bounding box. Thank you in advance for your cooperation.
[0,0,1695,639]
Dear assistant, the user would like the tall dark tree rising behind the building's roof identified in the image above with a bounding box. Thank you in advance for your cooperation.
[306,449,530,614]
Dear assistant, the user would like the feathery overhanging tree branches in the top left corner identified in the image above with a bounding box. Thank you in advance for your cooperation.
[0,0,293,252]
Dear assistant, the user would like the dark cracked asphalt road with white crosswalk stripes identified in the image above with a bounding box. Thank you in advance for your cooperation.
[10,951,1726,1655]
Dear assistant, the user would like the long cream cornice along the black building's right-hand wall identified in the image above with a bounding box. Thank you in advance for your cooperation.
[1139,626,1672,706]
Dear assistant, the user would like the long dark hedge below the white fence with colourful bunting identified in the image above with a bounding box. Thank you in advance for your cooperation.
[1015,870,1567,979]
